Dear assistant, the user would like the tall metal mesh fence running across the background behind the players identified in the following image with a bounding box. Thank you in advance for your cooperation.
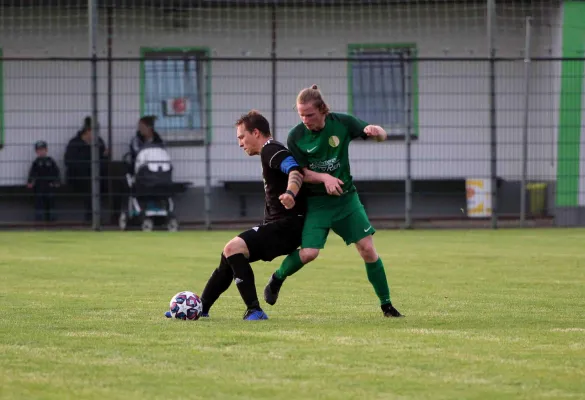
[0,0,585,229]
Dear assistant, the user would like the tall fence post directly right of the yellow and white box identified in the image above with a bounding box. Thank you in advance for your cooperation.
[487,0,498,229]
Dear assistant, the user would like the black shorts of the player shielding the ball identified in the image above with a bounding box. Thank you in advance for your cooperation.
[238,216,305,262]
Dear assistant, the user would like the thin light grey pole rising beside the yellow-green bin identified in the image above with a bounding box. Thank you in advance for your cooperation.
[520,17,532,227]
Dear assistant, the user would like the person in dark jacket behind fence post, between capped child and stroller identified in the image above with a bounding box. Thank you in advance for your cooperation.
[65,117,108,221]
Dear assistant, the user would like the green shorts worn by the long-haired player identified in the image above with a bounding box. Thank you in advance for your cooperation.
[301,192,376,249]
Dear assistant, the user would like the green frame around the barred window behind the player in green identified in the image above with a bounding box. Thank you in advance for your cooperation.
[347,43,419,140]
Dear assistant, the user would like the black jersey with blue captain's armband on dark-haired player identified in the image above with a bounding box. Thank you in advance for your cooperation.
[260,139,307,223]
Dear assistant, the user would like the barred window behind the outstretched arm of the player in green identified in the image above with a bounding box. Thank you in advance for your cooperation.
[348,45,418,139]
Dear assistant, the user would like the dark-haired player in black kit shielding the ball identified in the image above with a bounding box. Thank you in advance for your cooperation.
[167,110,306,320]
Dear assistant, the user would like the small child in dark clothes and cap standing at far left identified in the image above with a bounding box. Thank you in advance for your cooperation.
[26,140,61,221]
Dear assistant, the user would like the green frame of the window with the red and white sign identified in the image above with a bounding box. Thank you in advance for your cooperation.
[140,47,213,147]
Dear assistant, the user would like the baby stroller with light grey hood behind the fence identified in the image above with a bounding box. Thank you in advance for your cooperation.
[118,145,179,232]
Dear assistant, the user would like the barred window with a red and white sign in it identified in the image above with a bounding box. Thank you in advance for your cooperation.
[140,48,211,146]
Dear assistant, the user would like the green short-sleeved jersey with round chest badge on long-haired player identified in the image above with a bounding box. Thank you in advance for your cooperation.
[287,113,369,196]
